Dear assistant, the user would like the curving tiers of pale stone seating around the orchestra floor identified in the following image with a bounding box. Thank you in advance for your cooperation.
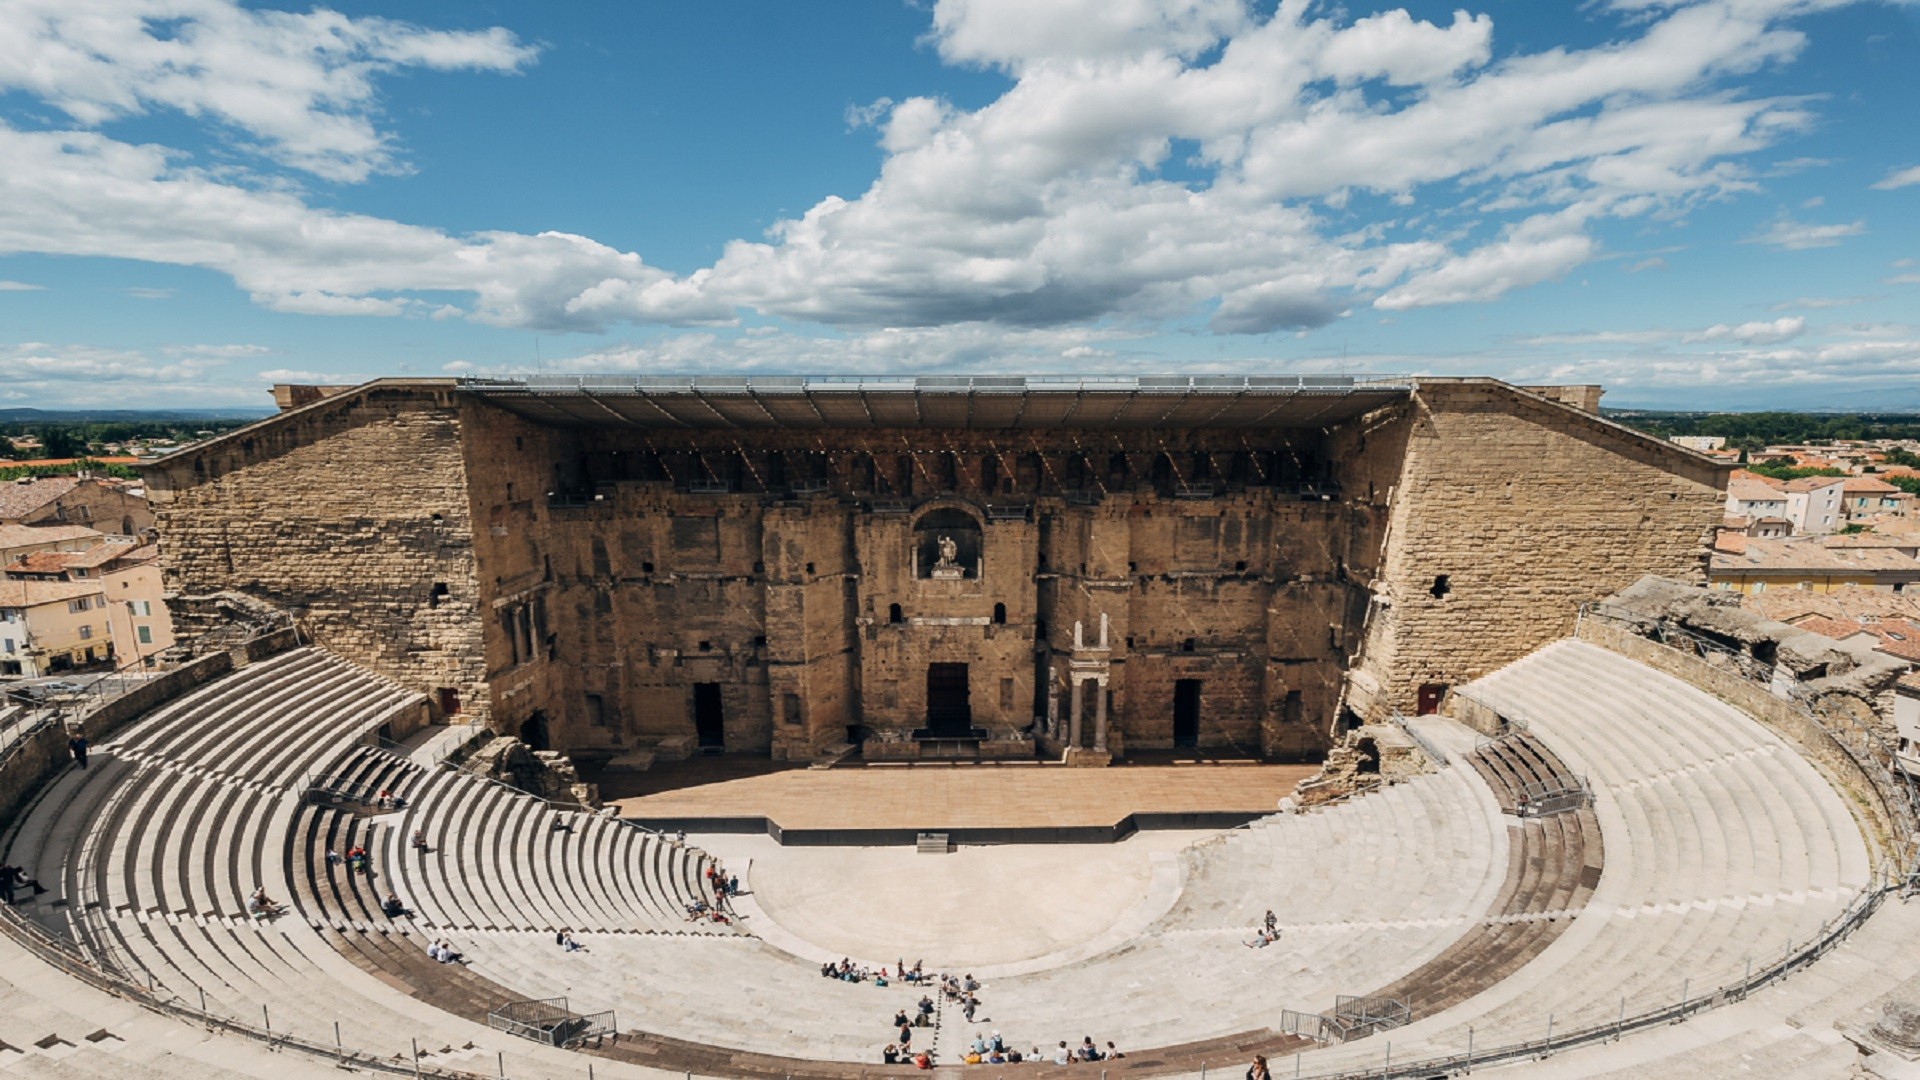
[0,630,1868,1078]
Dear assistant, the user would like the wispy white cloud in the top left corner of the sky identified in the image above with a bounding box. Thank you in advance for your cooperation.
[0,0,534,181]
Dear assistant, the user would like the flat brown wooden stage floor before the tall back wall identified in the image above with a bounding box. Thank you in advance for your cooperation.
[601,761,1317,832]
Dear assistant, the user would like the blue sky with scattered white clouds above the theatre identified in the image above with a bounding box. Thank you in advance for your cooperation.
[0,0,1920,409]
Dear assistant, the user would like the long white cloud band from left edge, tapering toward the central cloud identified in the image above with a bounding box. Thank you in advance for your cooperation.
[0,125,730,331]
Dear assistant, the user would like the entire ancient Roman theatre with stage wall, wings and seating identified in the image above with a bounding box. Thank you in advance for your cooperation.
[0,375,1920,1080]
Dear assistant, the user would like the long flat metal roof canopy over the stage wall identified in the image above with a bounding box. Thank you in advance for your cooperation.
[459,375,1413,430]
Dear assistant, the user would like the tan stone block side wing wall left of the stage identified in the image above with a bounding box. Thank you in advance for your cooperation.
[144,380,490,719]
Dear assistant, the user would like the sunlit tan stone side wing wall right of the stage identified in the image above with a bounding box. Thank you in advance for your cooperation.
[1348,379,1726,719]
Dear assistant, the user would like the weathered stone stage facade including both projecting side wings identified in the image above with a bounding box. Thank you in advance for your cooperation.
[139,380,1722,761]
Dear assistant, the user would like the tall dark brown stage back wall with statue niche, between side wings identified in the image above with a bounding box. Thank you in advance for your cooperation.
[487,420,1386,759]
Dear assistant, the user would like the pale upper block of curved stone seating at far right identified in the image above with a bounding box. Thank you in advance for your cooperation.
[1282,642,1870,1068]
